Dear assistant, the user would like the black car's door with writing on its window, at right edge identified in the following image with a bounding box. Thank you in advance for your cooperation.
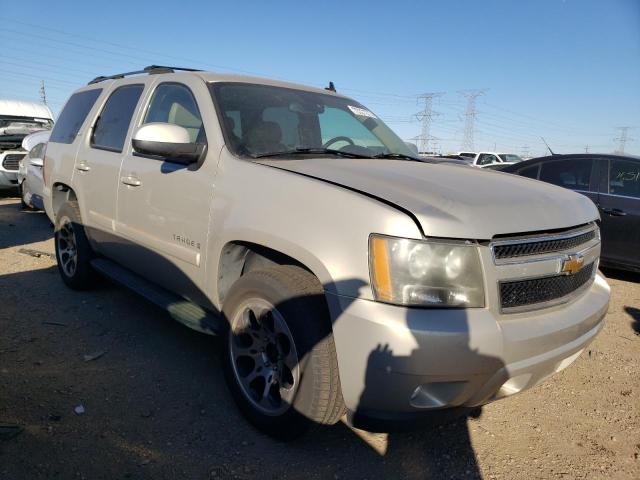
[600,158,640,268]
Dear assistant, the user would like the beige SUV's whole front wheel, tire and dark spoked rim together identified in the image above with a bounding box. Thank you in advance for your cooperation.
[222,265,345,440]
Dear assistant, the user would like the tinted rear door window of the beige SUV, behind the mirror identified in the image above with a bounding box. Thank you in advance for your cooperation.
[91,85,144,152]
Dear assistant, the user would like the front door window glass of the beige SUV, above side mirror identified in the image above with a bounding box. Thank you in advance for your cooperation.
[143,83,204,143]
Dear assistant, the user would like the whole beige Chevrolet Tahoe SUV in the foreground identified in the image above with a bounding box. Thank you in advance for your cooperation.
[44,66,609,437]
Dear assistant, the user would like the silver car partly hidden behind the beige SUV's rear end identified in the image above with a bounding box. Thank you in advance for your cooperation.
[18,130,51,210]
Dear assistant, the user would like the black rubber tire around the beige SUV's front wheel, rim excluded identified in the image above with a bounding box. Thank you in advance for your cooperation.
[222,265,345,440]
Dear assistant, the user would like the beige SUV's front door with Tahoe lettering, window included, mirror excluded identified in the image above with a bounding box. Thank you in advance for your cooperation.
[116,79,219,305]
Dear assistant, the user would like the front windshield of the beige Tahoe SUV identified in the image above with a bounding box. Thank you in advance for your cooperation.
[211,83,416,158]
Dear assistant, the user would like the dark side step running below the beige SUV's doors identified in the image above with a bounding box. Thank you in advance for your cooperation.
[91,258,223,335]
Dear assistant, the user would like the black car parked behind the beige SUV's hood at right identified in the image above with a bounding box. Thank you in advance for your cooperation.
[502,154,640,272]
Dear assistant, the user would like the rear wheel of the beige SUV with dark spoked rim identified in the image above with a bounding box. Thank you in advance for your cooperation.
[54,202,97,290]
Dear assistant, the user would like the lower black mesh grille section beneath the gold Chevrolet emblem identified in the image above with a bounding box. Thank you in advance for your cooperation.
[500,262,595,309]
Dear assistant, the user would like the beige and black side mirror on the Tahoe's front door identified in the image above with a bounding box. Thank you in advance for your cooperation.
[131,122,204,164]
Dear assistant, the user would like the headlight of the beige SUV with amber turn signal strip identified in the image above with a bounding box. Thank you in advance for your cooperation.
[369,235,484,308]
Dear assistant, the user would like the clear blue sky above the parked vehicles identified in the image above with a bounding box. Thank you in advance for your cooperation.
[0,0,640,155]
